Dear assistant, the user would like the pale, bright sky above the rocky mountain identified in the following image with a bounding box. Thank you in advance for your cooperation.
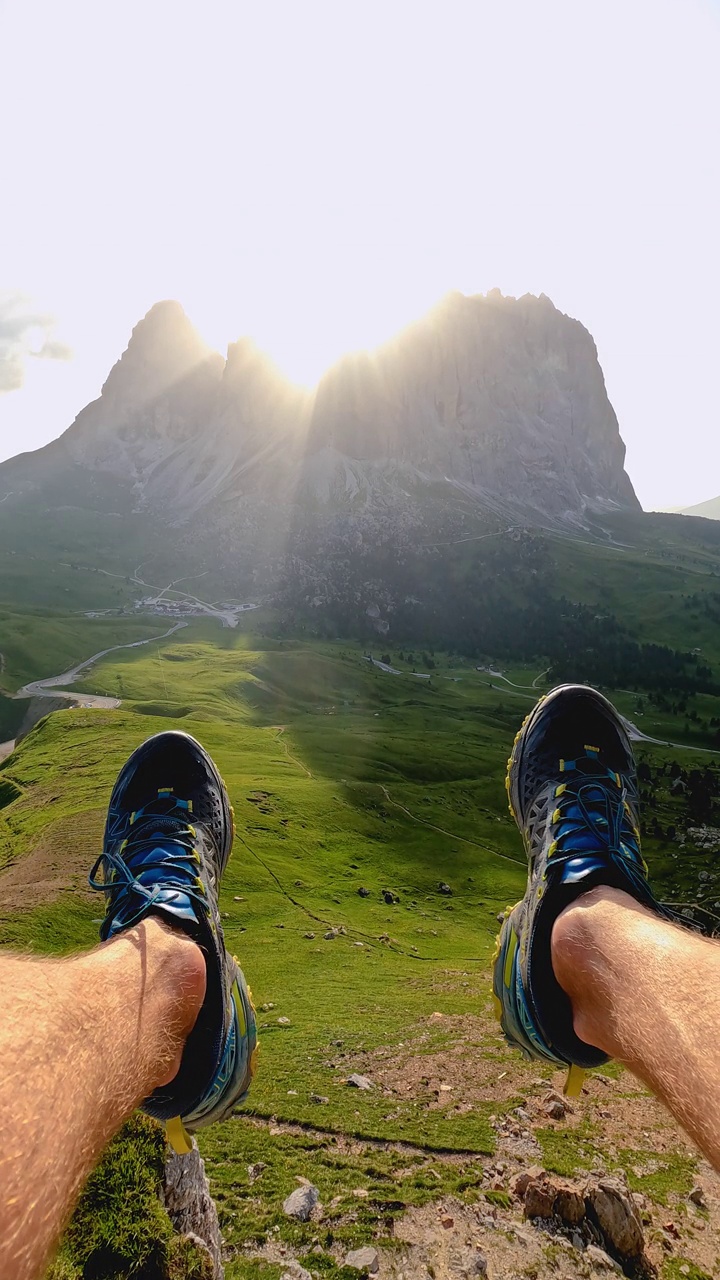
[0,0,720,508]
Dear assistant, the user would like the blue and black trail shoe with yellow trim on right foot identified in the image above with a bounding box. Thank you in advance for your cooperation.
[493,685,669,1094]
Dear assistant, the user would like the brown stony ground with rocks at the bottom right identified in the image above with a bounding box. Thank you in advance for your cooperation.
[221,1014,720,1280]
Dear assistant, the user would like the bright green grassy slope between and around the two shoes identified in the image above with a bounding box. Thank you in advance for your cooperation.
[0,623,703,1280]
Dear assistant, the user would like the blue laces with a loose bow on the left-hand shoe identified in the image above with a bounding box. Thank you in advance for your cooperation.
[88,791,208,928]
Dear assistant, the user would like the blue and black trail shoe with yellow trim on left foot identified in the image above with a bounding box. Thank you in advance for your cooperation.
[90,732,258,1152]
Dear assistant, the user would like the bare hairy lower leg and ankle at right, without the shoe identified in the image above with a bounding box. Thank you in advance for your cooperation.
[552,888,720,1170]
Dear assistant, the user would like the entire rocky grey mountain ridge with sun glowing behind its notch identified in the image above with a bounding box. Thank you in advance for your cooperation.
[0,291,638,536]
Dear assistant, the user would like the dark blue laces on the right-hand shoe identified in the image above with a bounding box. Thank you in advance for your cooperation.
[548,756,646,870]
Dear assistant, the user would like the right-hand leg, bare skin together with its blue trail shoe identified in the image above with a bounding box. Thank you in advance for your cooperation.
[493,686,720,1162]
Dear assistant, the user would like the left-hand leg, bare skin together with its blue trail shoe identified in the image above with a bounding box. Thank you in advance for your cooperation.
[0,732,256,1280]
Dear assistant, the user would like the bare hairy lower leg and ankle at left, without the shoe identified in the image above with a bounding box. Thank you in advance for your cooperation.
[0,918,205,1280]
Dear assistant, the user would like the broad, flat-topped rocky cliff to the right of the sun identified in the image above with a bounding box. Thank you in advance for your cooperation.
[302,291,638,516]
